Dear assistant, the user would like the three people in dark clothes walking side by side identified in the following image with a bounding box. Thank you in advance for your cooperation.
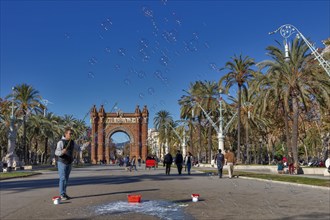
[164,150,194,175]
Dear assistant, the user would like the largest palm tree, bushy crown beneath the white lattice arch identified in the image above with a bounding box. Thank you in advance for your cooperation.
[258,38,330,162]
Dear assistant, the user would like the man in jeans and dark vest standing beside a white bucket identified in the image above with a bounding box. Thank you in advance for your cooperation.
[55,128,84,200]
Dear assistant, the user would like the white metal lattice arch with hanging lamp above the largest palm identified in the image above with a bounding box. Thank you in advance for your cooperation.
[269,24,330,77]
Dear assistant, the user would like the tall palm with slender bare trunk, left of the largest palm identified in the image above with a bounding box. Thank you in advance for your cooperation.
[219,55,255,161]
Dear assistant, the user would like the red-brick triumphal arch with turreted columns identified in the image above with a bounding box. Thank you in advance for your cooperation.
[91,105,149,164]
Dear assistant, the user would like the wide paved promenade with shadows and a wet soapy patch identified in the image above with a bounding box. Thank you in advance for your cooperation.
[0,166,330,220]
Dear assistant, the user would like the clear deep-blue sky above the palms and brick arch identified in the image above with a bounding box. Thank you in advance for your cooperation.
[0,0,330,143]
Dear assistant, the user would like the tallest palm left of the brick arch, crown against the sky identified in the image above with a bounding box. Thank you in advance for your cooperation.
[7,83,45,163]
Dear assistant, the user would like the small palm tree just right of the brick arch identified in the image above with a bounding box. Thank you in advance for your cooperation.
[154,110,173,153]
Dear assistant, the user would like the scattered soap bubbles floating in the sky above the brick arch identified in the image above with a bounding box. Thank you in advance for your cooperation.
[82,3,217,117]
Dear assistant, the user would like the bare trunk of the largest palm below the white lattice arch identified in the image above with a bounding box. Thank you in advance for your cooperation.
[291,96,299,162]
